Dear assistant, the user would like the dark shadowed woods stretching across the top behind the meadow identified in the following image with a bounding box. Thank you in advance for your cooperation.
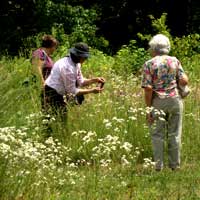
[0,0,200,55]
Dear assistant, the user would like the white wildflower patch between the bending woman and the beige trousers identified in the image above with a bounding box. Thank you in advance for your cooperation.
[72,129,140,167]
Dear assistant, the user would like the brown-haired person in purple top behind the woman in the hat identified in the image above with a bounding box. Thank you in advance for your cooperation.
[32,35,58,86]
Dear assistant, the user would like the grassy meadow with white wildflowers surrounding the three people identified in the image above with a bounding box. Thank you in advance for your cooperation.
[0,47,200,200]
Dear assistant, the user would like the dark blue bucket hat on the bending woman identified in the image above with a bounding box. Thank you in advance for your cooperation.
[69,42,90,58]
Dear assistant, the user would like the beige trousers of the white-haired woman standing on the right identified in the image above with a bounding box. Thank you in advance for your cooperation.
[150,97,183,169]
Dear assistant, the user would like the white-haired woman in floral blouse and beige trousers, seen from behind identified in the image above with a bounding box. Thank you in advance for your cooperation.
[142,34,188,171]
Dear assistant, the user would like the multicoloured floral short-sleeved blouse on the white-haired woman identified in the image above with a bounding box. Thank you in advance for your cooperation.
[142,55,185,98]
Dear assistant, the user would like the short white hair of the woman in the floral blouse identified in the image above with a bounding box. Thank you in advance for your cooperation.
[149,34,171,54]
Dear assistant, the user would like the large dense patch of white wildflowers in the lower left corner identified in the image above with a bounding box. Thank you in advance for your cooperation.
[0,127,80,198]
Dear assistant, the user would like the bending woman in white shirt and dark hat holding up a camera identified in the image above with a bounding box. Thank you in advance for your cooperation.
[44,42,105,118]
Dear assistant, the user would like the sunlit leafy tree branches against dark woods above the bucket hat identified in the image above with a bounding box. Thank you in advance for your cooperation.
[45,2,108,49]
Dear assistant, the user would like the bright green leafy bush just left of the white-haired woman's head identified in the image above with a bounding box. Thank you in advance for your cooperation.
[113,40,148,76]
